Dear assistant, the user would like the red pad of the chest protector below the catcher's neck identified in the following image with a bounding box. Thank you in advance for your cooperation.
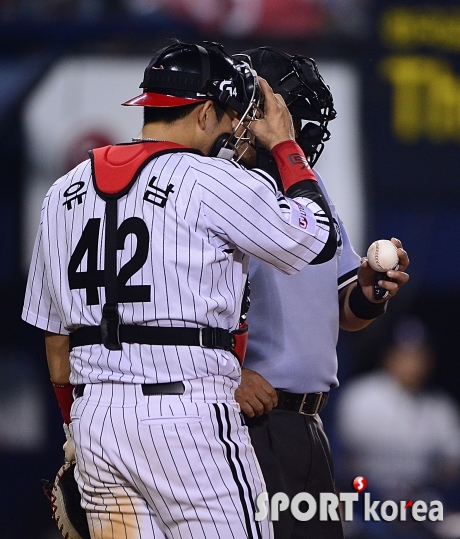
[89,142,192,198]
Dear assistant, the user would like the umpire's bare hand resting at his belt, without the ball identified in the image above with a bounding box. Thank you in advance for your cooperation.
[235,369,278,417]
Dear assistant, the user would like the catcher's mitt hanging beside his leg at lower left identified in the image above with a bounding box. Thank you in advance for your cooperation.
[43,461,91,539]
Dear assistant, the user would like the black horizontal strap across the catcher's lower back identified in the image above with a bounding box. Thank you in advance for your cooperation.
[69,324,235,351]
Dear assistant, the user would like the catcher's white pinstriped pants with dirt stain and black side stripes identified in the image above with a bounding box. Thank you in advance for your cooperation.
[71,377,273,539]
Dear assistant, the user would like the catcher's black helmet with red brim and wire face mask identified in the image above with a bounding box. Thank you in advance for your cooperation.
[123,40,262,159]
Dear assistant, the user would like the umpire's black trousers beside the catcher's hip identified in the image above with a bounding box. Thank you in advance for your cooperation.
[246,408,343,539]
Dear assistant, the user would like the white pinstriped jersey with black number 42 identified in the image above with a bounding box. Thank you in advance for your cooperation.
[23,144,329,384]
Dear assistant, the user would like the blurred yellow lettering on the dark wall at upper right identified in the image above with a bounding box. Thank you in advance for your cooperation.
[379,6,460,144]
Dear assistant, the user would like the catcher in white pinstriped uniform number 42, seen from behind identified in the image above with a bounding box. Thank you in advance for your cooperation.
[23,42,336,539]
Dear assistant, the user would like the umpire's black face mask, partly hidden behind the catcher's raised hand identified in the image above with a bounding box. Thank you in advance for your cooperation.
[234,47,337,166]
